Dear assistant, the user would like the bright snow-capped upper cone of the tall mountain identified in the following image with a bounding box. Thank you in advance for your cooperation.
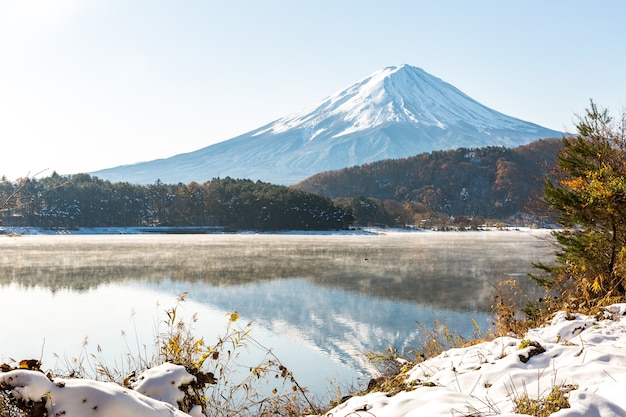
[264,64,521,137]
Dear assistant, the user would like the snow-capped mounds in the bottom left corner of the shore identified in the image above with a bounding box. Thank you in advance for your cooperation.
[0,363,201,417]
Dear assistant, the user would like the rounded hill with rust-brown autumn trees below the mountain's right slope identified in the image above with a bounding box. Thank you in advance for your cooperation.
[294,139,562,224]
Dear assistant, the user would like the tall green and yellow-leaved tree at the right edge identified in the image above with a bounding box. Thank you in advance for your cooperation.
[535,101,626,311]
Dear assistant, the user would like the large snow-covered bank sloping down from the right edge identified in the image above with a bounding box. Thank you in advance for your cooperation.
[312,304,626,417]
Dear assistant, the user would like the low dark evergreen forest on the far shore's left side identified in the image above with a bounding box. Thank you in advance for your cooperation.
[0,173,353,230]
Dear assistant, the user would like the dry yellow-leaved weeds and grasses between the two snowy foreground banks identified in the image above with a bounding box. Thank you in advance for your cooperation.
[0,294,321,417]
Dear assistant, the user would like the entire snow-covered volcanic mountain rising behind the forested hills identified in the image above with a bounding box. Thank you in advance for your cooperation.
[91,65,563,185]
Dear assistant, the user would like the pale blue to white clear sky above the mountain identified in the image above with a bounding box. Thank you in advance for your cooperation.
[0,0,626,179]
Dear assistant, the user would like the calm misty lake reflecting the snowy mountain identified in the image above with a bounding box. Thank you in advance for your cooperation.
[0,231,554,395]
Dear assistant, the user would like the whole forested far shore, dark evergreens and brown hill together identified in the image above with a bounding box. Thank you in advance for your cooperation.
[0,139,562,230]
